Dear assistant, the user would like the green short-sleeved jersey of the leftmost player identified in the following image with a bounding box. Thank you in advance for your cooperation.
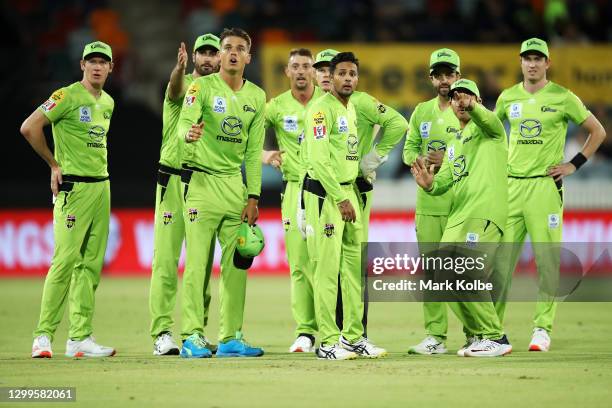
[40,82,115,178]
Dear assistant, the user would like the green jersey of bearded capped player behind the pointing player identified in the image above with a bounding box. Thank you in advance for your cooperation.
[403,97,460,215]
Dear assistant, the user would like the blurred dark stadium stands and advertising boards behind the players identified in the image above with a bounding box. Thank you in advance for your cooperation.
[0,0,612,276]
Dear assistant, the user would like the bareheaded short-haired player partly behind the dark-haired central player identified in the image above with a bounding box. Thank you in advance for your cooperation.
[265,48,324,353]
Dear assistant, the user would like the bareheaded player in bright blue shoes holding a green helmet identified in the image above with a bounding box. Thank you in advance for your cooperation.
[177,28,266,357]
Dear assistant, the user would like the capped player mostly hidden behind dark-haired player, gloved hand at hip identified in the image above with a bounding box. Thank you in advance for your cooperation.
[314,49,408,337]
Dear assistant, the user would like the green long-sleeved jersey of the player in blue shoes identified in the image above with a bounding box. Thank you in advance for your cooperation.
[177,73,266,197]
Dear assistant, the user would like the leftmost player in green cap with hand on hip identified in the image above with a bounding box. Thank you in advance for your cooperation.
[21,41,115,358]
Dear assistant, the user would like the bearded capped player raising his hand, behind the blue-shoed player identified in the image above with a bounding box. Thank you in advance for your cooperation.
[149,33,220,355]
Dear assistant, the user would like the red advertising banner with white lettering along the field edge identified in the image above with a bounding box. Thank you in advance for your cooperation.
[0,209,612,277]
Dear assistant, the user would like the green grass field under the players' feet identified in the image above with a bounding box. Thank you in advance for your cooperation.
[0,277,612,408]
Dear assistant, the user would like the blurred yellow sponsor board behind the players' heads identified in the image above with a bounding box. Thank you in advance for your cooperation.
[262,43,612,107]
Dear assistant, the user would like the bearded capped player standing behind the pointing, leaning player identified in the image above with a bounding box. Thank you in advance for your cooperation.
[402,48,462,355]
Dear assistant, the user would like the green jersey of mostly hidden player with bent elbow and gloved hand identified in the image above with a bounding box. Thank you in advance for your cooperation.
[351,91,408,161]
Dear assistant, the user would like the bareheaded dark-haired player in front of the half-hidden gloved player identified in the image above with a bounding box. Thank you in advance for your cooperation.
[302,52,386,360]
